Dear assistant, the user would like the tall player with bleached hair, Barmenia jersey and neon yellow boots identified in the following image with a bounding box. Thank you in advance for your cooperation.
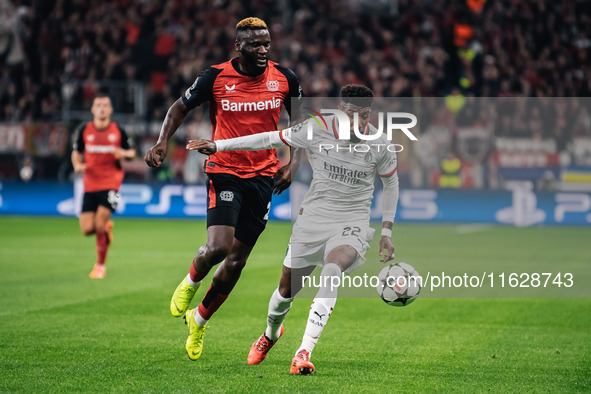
[145,18,302,360]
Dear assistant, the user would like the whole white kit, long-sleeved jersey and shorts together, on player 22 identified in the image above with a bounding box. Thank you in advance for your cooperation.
[215,116,398,273]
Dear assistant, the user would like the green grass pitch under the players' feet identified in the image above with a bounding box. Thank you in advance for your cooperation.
[0,217,591,393]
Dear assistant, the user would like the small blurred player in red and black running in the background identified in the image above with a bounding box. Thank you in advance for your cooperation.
[72,93,135,279]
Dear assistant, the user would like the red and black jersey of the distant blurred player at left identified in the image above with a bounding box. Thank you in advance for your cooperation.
[72,122,131,192]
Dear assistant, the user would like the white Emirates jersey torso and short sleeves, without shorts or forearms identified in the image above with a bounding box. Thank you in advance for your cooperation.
[280,116,397,228]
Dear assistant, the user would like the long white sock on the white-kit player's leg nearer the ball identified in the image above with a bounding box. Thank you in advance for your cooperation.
[296,263,341,355]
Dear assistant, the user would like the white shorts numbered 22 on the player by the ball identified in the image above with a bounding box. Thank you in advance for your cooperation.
[283,222,375,274]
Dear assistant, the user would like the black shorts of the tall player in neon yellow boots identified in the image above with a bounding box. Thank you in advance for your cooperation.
[207,174,273,246]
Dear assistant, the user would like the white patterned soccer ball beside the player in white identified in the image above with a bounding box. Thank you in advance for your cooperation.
[376,263,422,306]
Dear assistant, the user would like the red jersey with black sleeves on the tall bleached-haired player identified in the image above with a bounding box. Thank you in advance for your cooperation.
[182,58,302,178]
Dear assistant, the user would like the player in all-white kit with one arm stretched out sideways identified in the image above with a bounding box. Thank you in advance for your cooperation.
[187,85,398,375]
